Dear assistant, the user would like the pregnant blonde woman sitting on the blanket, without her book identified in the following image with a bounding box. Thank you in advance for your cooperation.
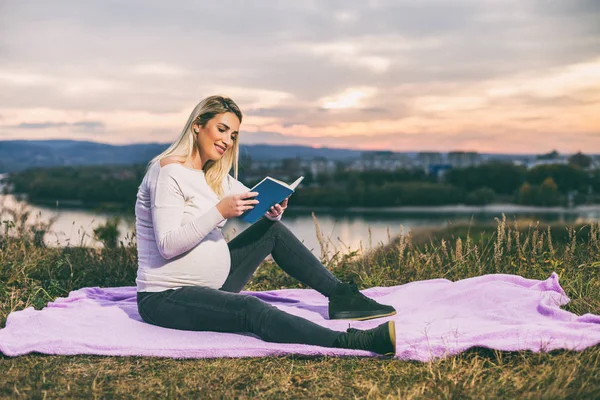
[135,96,396,355]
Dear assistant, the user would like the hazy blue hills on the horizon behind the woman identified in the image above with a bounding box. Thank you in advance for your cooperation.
[0,140,362,173]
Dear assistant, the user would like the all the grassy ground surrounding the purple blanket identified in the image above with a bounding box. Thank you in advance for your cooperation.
[0,202,600,399]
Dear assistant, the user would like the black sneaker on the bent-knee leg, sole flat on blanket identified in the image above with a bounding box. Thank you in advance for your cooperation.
[329,281,396,321]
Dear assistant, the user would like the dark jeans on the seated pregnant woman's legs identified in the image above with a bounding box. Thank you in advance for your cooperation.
[137,217,341,347]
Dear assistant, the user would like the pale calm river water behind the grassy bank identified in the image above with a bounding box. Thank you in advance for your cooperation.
[0,195,600,257]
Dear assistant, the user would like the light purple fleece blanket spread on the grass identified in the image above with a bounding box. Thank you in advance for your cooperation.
[0,273,600,361]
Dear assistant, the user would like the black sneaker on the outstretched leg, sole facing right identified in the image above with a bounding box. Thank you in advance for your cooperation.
[333,321,396,356]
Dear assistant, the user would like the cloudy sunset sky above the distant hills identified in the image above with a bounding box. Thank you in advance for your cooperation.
[0,0,600,153]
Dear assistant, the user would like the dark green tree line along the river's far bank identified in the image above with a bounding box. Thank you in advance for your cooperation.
[9,162,600,210]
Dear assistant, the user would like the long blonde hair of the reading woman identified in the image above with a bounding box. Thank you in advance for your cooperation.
[146,95,242,199]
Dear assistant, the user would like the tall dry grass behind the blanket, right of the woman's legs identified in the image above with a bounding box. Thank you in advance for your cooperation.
[313,214,600,318]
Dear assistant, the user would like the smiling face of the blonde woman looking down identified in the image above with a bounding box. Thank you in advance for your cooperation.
[193,112,240,163]
